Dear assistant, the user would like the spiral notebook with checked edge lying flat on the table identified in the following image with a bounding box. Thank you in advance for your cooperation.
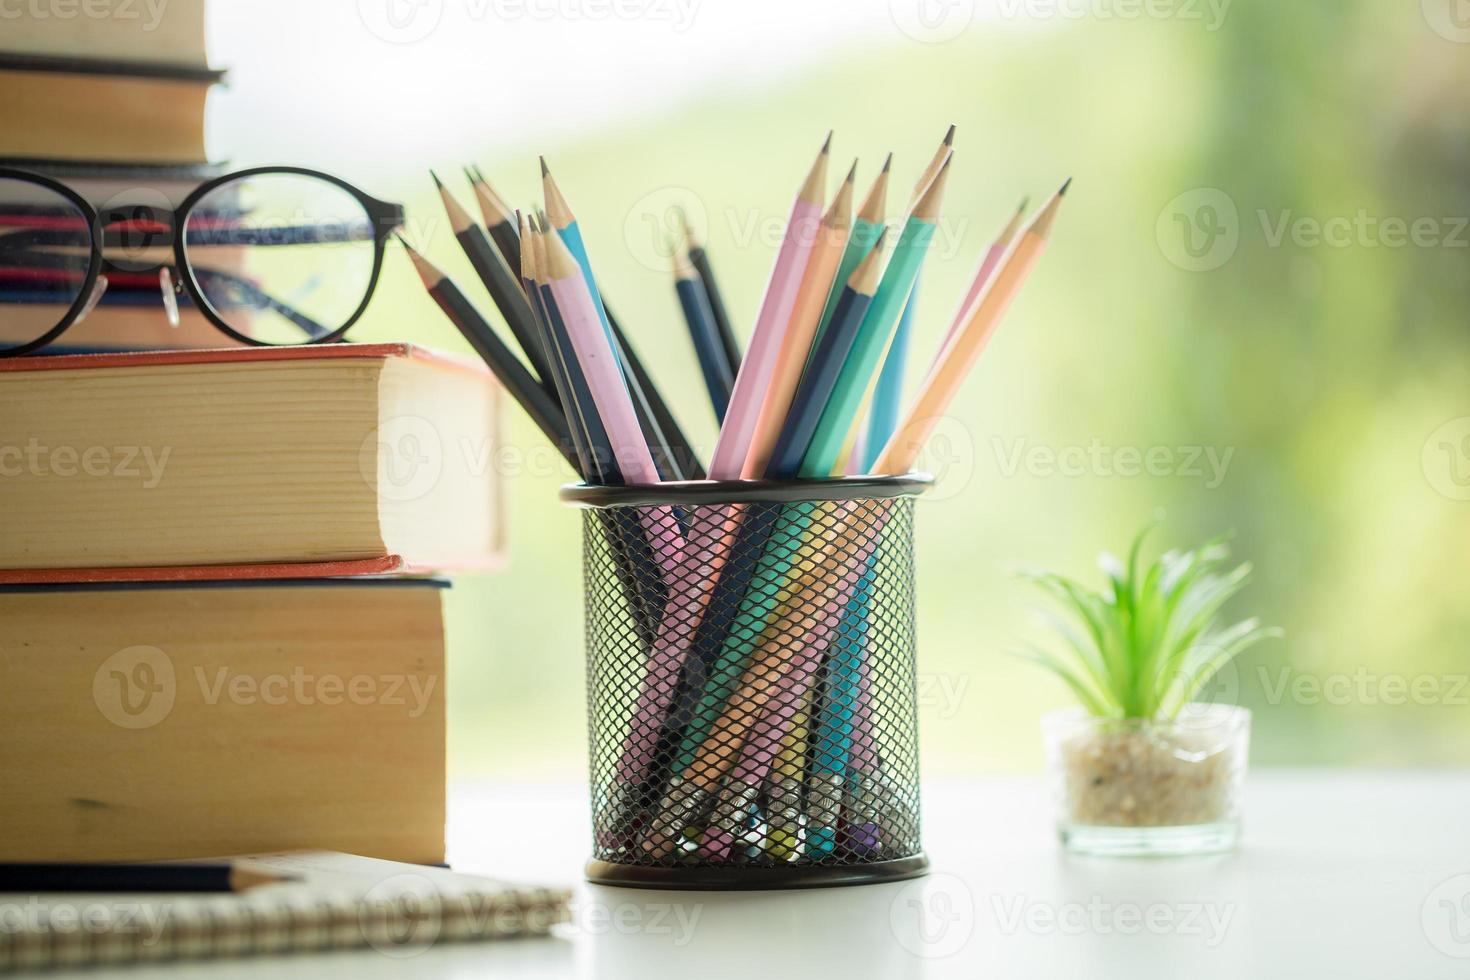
[0,852,570,973]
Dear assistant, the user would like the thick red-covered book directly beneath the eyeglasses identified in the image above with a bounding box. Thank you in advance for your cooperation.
[0,344,504,583]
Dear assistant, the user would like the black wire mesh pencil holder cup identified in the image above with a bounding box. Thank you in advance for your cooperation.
[562,476,929,889]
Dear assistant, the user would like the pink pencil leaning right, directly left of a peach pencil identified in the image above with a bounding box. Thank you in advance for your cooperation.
[710,132,832,480]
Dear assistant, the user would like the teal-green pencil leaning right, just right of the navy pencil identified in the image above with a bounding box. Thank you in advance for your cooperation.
[800,156,954,479]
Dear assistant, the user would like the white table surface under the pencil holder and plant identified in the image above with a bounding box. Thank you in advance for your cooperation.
[42,770,1470,980]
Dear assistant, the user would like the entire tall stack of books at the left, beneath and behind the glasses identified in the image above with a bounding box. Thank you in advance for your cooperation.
[0,0,501,862]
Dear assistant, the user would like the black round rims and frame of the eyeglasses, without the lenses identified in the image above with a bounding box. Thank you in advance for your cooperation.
[0,166,404,357]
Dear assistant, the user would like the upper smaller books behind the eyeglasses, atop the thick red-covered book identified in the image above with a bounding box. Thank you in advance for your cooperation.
[0,0,234,354]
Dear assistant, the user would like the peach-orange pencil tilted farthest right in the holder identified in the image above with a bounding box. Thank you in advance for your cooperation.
[873,181,1072,473]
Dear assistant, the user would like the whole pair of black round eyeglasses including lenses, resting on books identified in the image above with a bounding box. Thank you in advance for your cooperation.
[0,167,403,357]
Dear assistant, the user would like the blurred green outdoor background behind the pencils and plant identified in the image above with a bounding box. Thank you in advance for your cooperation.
[216,0,1470,777]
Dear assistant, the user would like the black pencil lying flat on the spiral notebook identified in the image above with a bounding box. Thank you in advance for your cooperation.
[0,861,300,893]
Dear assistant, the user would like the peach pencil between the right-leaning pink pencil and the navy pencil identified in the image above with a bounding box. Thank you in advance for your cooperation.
[741,160,857,479]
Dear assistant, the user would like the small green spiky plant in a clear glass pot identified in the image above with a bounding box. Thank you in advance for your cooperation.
[1023,529,1280,855]
